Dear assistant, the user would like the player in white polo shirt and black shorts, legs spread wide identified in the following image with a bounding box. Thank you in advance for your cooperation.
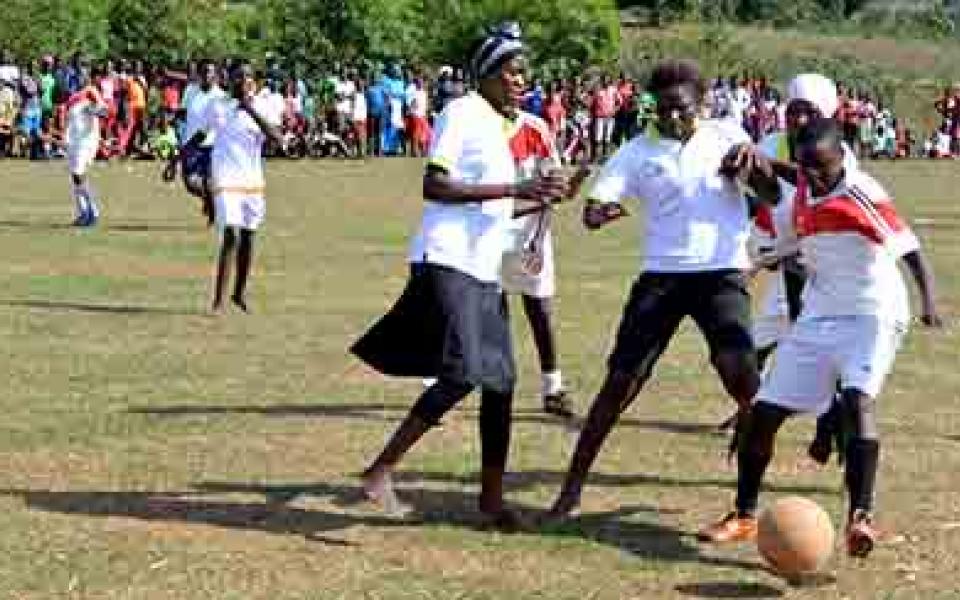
[547,61,779,520]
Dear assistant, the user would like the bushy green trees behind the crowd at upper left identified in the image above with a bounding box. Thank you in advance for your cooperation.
[0,0,620,73]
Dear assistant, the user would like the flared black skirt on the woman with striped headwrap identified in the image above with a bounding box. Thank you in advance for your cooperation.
[350,263,516,393]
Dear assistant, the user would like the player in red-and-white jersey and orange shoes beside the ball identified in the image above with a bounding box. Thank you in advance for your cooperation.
[699,119,914,557]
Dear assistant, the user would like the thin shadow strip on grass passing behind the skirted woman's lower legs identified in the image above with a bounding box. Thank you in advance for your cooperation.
[130,399,718,437]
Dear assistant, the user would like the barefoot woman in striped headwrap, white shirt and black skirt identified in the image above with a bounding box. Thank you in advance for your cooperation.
[351,25,567,530]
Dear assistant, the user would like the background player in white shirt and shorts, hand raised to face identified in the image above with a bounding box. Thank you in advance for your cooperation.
[178,64,282,312]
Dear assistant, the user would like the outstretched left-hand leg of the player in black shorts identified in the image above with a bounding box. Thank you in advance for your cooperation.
[548,273,684,520]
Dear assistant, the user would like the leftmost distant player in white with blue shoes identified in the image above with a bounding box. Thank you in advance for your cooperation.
[64,67,107,227]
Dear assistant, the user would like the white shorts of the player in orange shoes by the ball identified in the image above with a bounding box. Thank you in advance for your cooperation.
[758,316,906,414]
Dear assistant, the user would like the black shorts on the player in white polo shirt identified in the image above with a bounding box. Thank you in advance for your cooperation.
[607,270,755,379]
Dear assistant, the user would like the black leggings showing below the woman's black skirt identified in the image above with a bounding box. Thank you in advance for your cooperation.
[412,378,513,469]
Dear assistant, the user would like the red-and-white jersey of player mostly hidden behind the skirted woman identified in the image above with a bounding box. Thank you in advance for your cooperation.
[509,111,560,250]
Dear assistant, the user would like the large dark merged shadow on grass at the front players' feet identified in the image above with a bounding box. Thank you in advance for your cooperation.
[0,482,764,571]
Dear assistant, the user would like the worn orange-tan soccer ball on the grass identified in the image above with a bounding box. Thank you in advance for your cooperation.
[757,496,835,579]
